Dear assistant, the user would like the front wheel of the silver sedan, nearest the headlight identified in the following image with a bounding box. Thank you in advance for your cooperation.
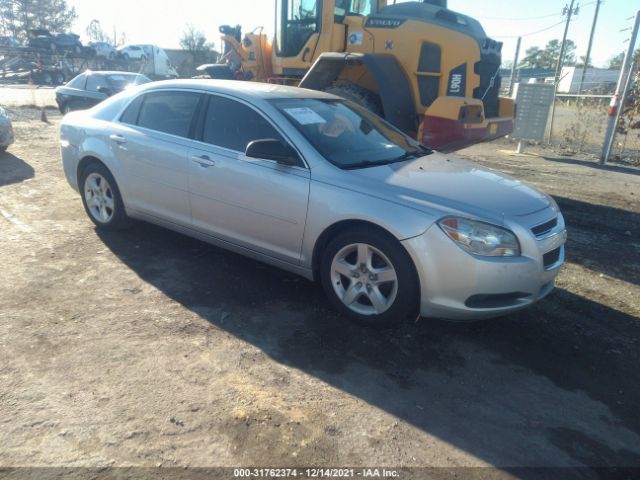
[320,229,419,327]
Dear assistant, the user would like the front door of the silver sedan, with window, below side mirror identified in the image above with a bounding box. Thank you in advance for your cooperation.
[189,95,310,263]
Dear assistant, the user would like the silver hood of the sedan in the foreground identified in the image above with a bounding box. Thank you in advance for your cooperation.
[340,152,552,217]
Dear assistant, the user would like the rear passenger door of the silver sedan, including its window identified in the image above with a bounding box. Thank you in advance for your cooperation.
[110,90,202,226]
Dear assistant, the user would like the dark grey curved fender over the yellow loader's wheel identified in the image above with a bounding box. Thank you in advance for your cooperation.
[298,53,418,132]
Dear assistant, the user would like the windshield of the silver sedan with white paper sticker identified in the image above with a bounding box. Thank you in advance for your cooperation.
[271,98,431,169]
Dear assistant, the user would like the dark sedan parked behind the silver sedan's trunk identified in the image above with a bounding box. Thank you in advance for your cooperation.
[55,71,151,114]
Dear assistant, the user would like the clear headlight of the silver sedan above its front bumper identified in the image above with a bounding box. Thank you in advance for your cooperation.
[438,217,520,257]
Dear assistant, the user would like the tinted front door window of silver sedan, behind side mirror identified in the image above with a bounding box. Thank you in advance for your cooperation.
[202,96,284,152]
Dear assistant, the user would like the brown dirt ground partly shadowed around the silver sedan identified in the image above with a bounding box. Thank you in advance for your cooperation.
[0,109,640,478]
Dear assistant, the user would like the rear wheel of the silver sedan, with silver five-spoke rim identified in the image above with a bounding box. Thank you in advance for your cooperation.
[80,162,129,230]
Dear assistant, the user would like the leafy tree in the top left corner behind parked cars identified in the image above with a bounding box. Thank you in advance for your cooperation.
[0,0,78,40]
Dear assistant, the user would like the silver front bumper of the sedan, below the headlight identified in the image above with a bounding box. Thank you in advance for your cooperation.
[402,214,566,320]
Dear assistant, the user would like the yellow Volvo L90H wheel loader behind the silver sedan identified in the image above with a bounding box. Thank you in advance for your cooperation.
[210,0,514,151]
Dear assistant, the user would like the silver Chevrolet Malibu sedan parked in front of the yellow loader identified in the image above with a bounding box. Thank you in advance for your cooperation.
[60,80,566,325]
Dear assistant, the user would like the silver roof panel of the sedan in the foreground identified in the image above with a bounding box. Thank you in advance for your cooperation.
[138,79,339,99]
